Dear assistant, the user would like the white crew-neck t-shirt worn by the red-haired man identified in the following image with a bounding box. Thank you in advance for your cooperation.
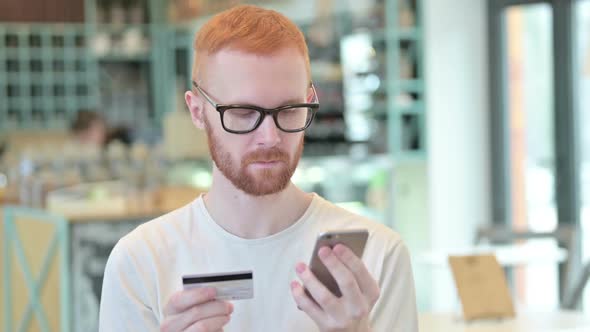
[99,194,418,332]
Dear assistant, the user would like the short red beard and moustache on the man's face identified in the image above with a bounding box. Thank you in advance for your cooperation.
[204,117,303,196]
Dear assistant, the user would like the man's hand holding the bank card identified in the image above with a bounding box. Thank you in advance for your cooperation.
[160,288,233,332]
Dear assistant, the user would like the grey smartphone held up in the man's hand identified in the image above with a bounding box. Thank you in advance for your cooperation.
[306,229,369,297]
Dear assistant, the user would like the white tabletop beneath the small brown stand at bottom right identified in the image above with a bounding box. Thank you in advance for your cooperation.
[419,311,590,332]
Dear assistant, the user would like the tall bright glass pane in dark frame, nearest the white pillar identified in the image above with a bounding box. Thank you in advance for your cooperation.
[505,3,557,231]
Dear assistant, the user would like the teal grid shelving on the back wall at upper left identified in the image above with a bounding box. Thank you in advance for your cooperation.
[0,23,97,130]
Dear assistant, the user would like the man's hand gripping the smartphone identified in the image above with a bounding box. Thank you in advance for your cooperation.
[291,244,380,332]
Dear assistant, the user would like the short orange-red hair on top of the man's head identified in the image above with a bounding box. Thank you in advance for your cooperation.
[193,5,311,80]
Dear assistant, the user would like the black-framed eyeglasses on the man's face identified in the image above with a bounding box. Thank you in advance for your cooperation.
[193,81,320,134]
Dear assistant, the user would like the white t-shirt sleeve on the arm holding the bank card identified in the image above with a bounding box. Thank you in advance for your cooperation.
[99,241,159,332]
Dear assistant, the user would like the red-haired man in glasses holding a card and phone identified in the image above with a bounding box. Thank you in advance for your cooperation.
[100,6,417,332]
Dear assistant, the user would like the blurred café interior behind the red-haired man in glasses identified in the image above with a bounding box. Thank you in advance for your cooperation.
[0,0,590,331]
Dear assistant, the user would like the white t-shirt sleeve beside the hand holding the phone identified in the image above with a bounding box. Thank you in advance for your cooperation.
[371,241,418,332]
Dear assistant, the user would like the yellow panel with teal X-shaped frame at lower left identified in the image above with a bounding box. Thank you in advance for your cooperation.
[0,207,71,332]
